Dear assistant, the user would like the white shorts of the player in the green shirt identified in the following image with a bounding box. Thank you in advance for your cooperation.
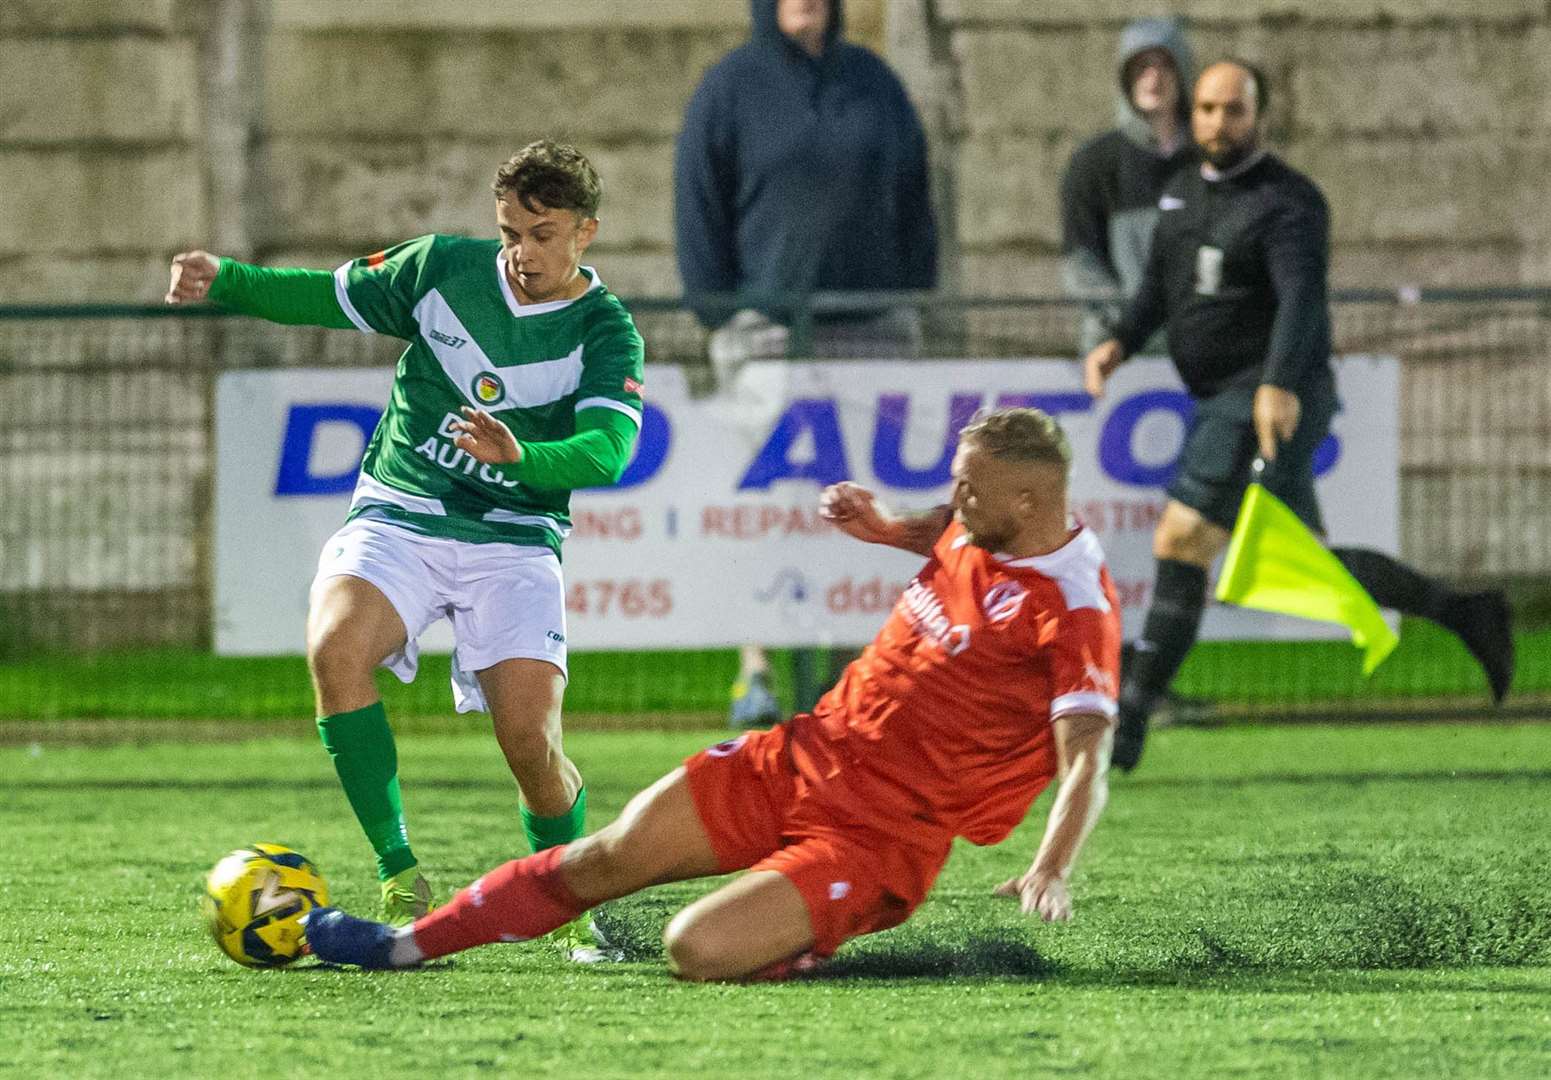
[313,518,566,712]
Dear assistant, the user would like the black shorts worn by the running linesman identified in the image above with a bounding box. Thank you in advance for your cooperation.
[1168,376,1337,534]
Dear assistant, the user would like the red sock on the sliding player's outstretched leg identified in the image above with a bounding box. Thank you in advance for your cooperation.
[414,844,589,959]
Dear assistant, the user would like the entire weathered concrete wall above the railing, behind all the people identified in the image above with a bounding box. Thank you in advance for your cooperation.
[0,0,1551,303]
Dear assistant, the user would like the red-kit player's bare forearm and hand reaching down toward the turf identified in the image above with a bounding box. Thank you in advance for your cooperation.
[996,712,1112,922]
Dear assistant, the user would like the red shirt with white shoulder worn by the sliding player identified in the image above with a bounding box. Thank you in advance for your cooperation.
[791,521,1120,844]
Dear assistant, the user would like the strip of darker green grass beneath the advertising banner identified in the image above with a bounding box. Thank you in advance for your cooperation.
[0,619,1551,726]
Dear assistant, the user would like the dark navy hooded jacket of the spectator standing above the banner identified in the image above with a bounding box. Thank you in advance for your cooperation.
[673,0,937,326]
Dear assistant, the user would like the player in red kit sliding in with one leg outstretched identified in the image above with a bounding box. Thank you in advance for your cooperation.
[307,408,1120,979]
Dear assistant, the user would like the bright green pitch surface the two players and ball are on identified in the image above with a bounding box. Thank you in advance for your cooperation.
[0,725,1551,1080]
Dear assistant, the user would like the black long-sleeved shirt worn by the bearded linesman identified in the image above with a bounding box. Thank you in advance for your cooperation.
[1115,154,1331,397]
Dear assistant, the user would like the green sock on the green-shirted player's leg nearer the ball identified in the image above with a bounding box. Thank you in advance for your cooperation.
[318,701,416,881]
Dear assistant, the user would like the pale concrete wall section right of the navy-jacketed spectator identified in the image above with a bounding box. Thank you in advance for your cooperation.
[937,0,1551,292]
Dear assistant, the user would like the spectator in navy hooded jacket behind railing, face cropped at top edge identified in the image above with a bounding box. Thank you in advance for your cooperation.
[673,0,937,726]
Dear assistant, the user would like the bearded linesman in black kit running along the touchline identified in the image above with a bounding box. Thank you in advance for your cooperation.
[1084,61,1514,770]
